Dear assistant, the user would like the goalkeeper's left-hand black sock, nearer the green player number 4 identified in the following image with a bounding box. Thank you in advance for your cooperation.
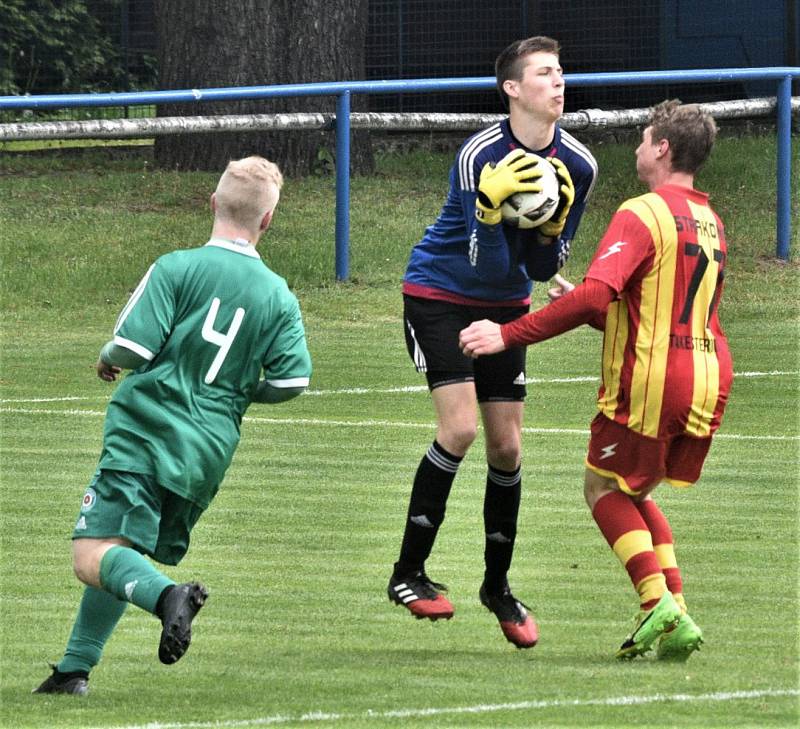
[394,441,461,577]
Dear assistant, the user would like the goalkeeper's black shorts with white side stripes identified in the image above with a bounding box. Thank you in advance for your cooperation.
[403,294,528,402]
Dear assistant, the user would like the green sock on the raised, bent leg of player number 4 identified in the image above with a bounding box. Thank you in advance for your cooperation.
[100,546,175,615]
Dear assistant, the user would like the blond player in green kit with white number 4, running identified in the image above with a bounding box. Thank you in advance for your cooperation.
[35,157,311,695]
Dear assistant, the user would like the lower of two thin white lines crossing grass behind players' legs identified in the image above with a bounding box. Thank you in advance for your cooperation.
[0,408,800,441]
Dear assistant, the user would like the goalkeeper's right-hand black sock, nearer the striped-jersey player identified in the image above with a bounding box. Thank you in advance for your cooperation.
[483,466,522,593]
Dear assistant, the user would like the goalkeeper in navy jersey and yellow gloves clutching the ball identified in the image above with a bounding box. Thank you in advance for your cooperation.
[387,36,597,648]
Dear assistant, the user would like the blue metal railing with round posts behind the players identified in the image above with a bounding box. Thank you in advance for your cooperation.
[0,66,800,280]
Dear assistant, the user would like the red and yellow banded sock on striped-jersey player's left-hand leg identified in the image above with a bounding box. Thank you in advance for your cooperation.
[592,491,667,610]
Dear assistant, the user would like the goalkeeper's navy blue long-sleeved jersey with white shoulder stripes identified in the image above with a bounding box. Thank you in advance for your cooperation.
[403,119,597,306]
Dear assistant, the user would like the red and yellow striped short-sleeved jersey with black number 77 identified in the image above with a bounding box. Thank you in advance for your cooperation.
[586,185,733,438]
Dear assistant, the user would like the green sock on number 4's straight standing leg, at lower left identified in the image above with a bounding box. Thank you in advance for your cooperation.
[58,587,128,673]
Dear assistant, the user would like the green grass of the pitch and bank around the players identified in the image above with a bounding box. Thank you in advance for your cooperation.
[0,139,800,729]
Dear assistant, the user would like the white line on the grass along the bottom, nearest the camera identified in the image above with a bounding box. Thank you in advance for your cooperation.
[90,689,800,729]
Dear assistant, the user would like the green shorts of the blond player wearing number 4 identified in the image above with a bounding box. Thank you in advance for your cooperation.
[72,470,203,565]
